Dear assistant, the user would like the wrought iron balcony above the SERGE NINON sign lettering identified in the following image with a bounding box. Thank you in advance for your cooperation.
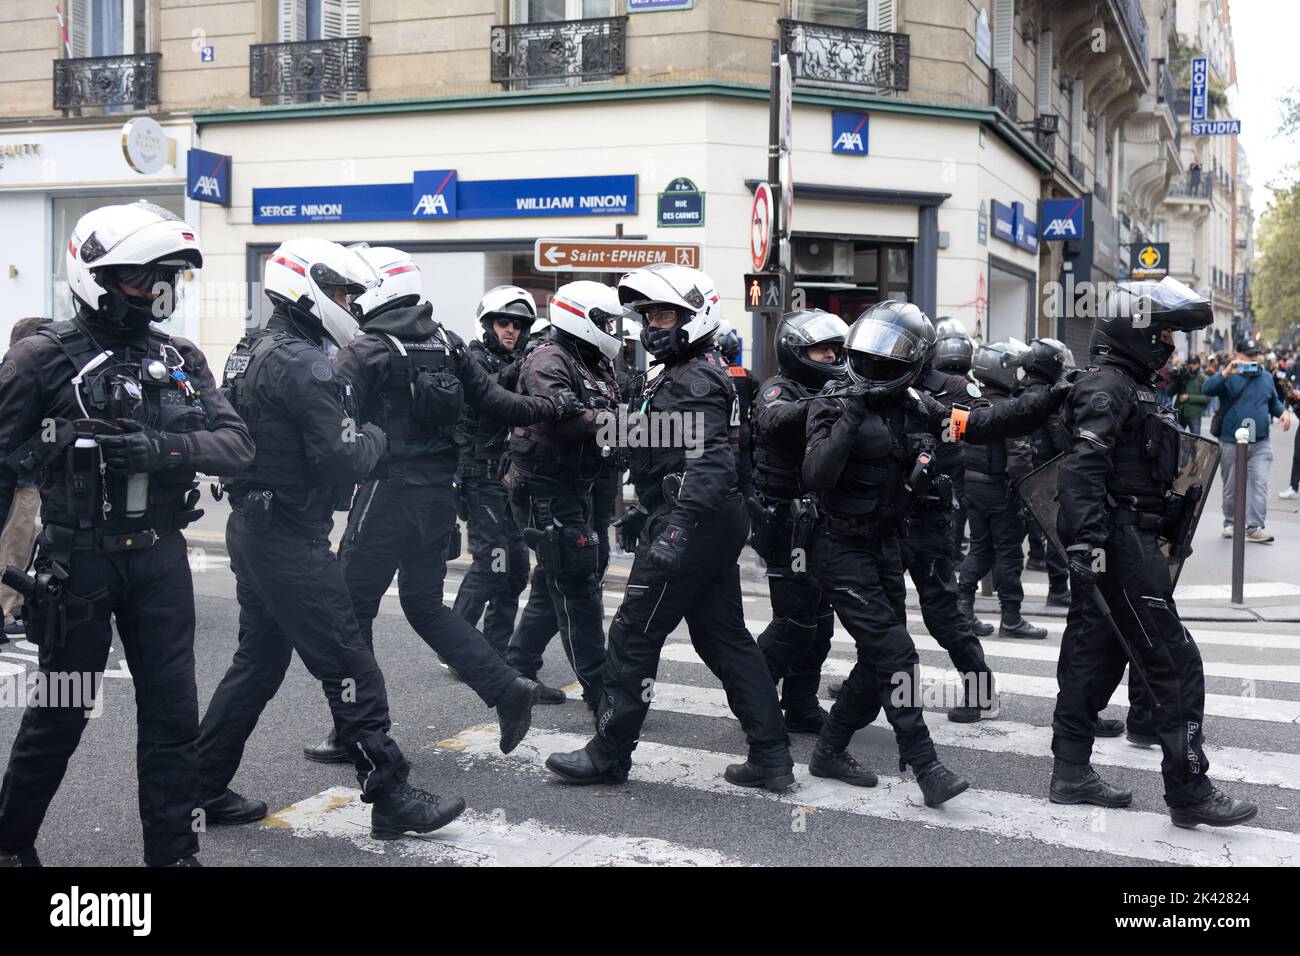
[248,36,371,100]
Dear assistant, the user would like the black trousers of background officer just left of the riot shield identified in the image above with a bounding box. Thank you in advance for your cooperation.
[957,475,1024,615]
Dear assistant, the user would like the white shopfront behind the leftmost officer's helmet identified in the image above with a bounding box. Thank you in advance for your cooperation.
[0,117,198,343]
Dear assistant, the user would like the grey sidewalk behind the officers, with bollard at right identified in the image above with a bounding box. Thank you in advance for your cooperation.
[185,424,1300,622]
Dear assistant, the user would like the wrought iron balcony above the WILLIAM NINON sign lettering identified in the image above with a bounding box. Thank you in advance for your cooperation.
[490,17,628,87]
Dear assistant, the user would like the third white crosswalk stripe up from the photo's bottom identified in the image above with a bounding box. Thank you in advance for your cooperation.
[634,683,1300,790]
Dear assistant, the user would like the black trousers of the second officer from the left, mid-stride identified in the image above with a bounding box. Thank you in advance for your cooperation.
[199,502,408,801]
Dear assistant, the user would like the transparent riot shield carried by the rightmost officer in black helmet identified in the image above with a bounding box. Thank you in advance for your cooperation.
[1017,432,1219,588]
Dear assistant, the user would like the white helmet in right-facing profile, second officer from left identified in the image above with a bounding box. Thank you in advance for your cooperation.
[263,239,380,349]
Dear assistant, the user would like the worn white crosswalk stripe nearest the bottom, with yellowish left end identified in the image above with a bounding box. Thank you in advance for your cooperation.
[261,787,742,866]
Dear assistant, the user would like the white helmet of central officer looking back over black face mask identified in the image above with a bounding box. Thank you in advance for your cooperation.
[619,263,723,359]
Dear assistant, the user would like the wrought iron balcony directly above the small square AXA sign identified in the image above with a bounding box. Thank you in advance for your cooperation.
[780,20,911,92]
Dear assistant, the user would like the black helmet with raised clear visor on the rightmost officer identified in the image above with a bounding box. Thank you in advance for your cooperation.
[1089,276,1214,372]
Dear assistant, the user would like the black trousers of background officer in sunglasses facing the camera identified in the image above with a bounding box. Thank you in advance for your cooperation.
[452,477,528,656]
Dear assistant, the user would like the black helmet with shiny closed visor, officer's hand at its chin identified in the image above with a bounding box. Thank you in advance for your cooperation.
[844,299,935,399]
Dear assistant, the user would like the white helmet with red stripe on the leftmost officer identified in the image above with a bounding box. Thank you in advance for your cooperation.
[65,202,203,328]
